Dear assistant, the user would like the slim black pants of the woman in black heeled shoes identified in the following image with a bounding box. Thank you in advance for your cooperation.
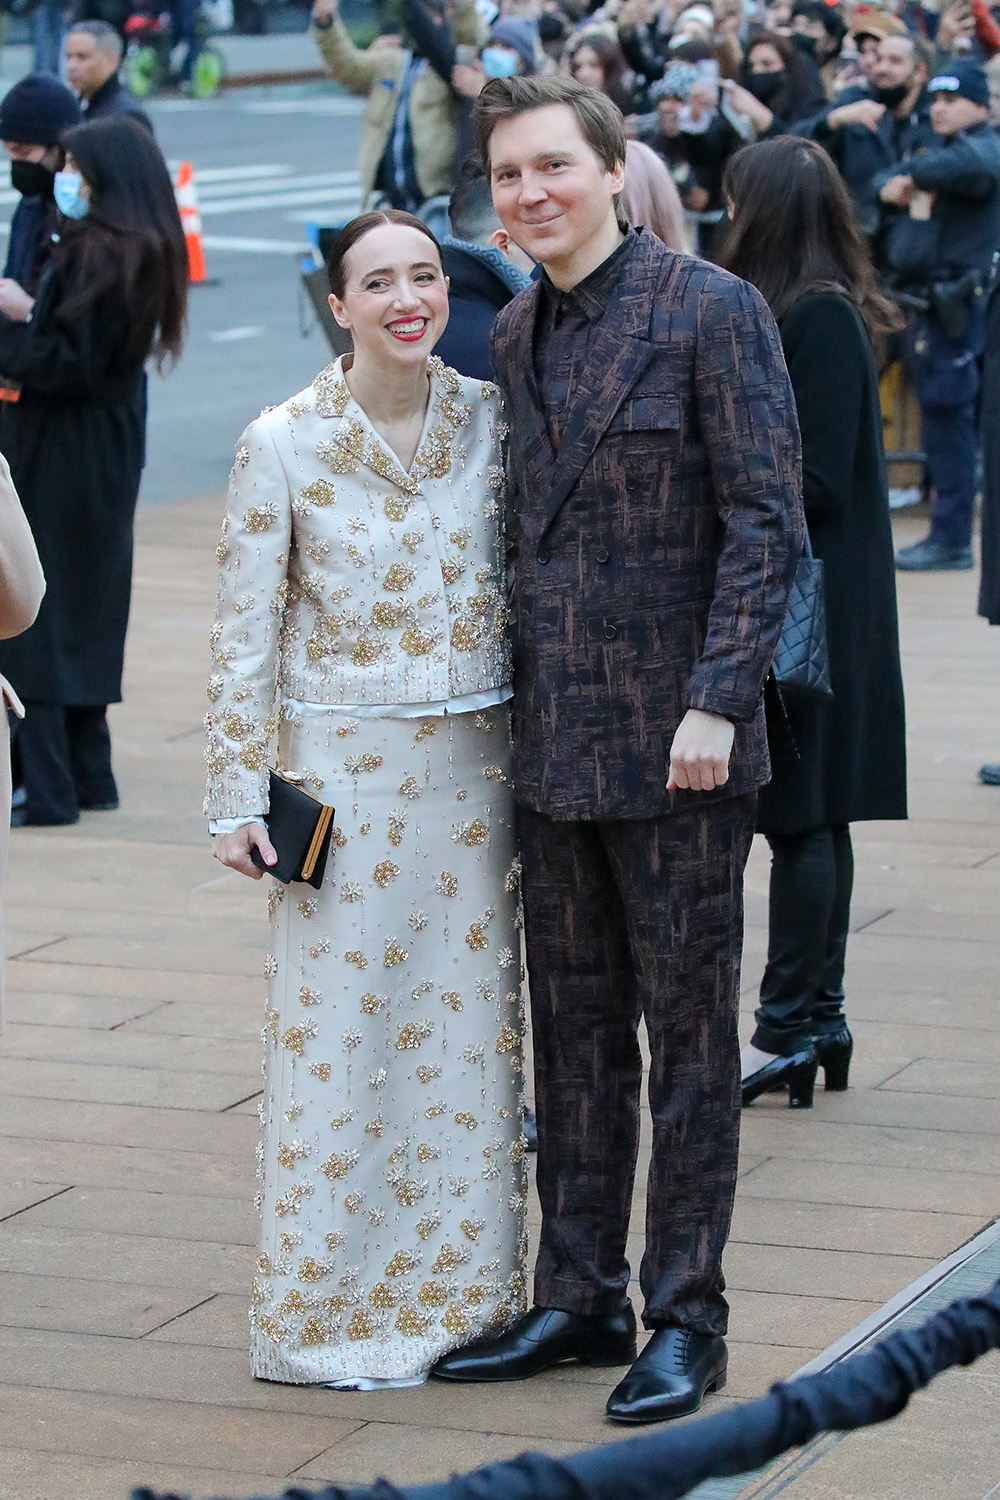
[753,824,855,1058]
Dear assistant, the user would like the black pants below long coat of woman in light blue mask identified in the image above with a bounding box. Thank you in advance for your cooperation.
[13,702,118,824]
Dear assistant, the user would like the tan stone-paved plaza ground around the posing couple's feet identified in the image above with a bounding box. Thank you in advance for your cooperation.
[0,497,1000,1500]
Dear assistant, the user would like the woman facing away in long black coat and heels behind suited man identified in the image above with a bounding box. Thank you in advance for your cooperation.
[723,137,906,1107]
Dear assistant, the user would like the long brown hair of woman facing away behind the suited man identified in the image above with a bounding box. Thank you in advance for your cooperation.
[720,135,900,338]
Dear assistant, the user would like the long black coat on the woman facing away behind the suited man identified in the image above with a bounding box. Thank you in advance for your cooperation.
[757,293,906,836]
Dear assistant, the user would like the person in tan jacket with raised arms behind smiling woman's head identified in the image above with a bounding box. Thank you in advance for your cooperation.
[312,0,487,213]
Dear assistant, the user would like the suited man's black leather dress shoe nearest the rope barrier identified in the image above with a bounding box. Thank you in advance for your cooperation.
[607,1328,729,1422]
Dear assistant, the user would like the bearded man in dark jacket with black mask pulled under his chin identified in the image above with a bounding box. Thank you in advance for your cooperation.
[795,33,934,272]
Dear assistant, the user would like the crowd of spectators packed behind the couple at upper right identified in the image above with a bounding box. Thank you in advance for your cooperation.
[313,0,1000,582]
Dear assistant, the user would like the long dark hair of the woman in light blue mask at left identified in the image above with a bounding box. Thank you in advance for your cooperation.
[57,116,189,366]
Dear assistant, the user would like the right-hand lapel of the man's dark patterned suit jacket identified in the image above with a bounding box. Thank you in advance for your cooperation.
[543,234,663,533]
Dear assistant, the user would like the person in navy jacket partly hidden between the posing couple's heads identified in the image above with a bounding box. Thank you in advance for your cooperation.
[435,158,532,380]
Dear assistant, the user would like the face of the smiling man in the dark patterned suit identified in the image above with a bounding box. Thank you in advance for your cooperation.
[490,104,625,267]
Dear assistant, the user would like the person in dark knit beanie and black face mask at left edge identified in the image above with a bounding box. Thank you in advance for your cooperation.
[0,74,79,296]
